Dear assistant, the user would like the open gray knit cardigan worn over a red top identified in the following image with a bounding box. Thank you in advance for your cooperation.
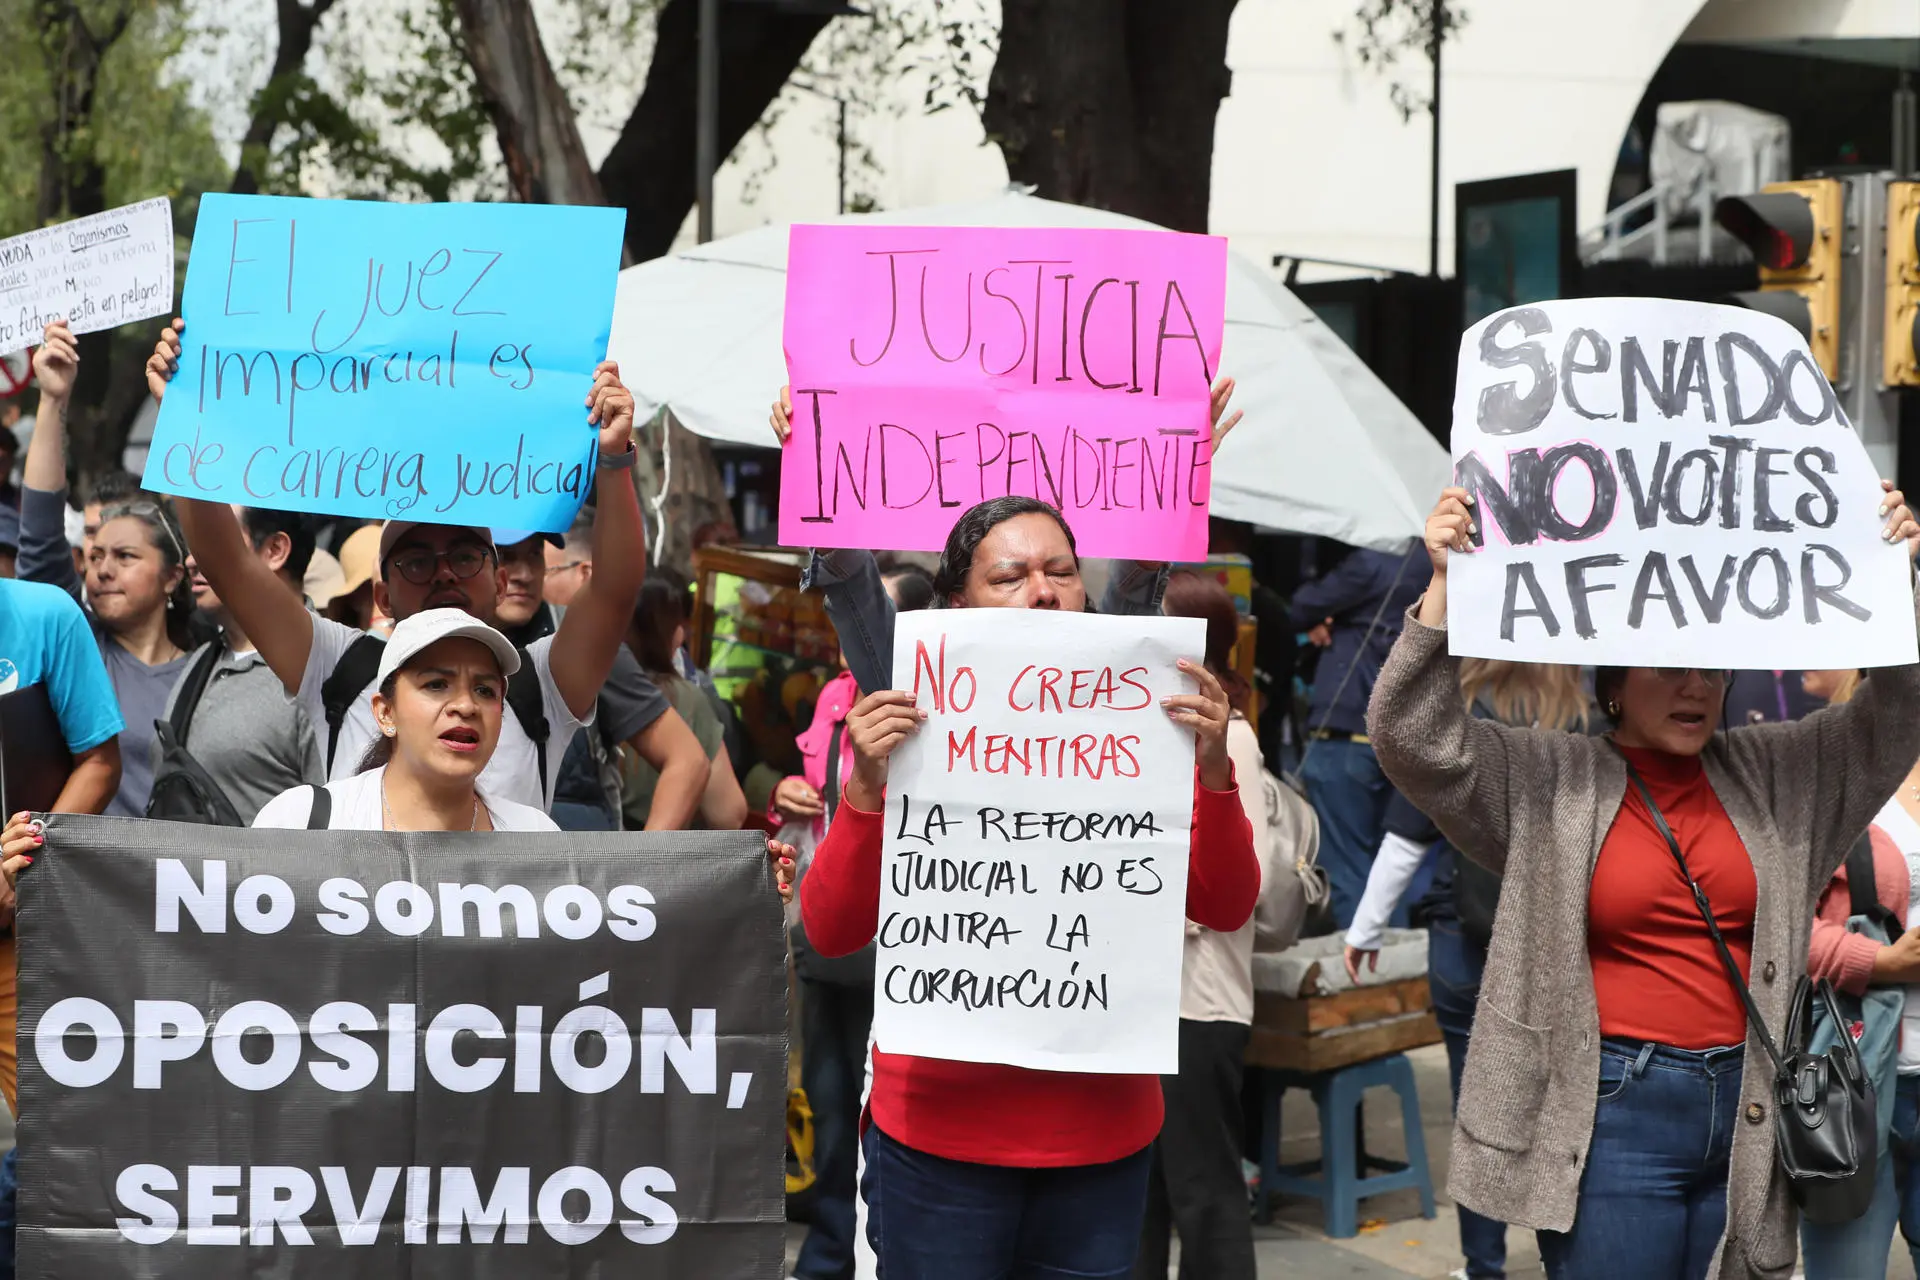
[1367,594,1920,1280]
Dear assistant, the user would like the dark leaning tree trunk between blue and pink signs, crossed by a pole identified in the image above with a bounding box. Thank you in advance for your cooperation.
[599,0,828,261]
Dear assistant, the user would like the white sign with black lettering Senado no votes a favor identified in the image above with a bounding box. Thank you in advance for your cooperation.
[1448,297,1914,670]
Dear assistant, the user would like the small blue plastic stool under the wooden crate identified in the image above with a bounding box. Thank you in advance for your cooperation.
[1256,1054,1436,1240]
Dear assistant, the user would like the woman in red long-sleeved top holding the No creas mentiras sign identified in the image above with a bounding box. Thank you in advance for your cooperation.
[801,497,1260,1280]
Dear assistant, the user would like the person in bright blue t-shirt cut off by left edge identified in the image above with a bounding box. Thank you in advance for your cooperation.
[0,578,127,1276]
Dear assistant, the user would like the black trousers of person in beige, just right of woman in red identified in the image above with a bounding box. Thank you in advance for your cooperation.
[1133,1019,1254,1280]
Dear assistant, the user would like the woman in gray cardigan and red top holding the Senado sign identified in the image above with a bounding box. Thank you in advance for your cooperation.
[1369,486,1920,1280]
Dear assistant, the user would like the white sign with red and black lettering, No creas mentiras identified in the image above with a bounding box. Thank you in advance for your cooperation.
[874,608,1206,1075]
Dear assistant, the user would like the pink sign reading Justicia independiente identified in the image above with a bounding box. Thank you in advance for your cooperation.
[780,225,1227,560]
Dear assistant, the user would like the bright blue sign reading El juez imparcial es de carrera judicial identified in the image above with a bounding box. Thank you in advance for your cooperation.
[144,194,626,530]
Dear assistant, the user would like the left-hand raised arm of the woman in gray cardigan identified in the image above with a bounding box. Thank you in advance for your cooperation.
[1367,489,1519,871]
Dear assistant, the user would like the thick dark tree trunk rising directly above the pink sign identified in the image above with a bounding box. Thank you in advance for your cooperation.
[985,0,1235,232]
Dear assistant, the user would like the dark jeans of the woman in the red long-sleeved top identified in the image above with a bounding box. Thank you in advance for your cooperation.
[860,1109,1152,1280]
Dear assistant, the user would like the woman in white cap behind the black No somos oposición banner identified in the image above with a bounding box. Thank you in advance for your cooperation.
[253,608,559,831]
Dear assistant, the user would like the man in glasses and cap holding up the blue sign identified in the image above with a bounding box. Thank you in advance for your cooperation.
[146,320,647,810]
